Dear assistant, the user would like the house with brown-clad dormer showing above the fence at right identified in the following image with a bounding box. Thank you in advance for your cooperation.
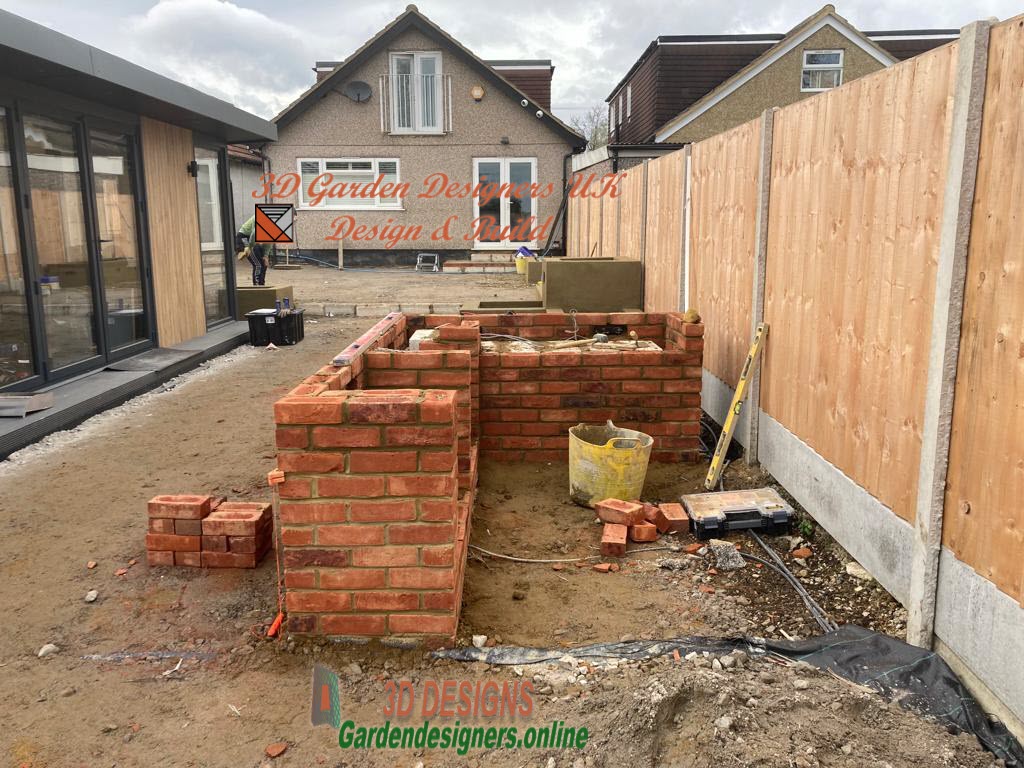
[593,5,959,166]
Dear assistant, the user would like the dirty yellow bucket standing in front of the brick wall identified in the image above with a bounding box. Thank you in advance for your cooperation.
[569,421,654,508]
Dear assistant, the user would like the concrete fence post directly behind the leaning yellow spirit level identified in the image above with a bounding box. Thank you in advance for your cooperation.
[742,108,778,467]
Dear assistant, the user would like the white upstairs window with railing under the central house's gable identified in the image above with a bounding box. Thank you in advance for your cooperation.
[389,52,442,133]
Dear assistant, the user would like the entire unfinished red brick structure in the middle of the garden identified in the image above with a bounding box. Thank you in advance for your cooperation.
[274,312,703,645]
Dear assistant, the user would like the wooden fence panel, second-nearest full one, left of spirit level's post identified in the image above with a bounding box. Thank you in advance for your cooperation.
[689,118,761,387]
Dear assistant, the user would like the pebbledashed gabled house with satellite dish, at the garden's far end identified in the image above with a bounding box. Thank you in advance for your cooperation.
[266,5,586,263]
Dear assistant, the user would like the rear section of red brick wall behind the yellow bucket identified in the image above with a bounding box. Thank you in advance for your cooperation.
[412,312,703,462]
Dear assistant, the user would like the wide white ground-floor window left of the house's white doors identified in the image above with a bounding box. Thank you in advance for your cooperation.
[299,158,401,211]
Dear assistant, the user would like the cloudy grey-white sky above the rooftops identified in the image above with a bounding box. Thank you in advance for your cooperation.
[0,0,1024,120]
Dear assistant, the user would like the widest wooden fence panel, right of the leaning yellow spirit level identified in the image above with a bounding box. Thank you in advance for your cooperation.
[761,45,956,521]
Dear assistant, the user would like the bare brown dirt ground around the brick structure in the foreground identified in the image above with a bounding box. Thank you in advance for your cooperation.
[0,279,994,768]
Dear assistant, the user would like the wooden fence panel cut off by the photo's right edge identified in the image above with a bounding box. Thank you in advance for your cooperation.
[942,18,1024,600]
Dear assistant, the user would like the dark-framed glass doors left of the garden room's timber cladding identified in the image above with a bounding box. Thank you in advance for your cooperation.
[0,100,154,389]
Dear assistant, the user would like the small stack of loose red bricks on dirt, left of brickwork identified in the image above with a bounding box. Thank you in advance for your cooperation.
[145,495,273,568]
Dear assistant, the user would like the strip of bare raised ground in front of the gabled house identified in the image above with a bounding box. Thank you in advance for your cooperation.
[238,262,538,304]
